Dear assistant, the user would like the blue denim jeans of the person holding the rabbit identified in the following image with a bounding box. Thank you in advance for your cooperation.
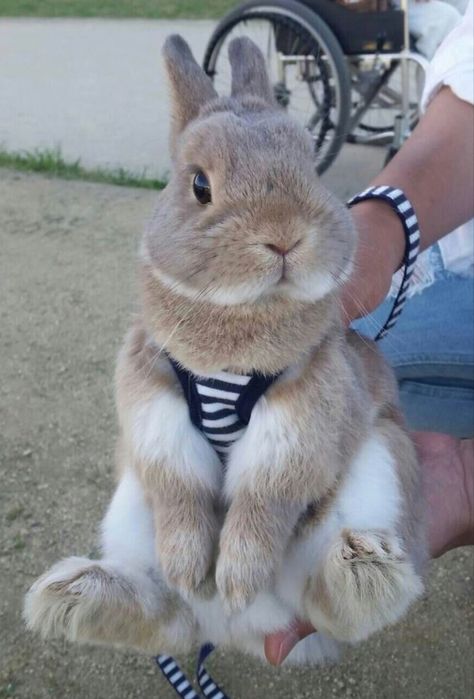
[353,252,474,437]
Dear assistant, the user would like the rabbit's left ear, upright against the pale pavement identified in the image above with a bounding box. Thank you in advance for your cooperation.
[163,34,217,142]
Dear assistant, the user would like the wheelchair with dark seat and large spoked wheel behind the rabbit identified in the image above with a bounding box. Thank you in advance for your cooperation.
[204,0,427,174]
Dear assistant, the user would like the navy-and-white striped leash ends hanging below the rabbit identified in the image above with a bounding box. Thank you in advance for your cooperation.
[155,643,230,699]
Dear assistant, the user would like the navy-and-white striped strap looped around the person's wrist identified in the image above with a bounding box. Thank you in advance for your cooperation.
[347,185,420,341]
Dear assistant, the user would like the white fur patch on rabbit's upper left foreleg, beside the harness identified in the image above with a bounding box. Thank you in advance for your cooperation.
[132,390,222,491]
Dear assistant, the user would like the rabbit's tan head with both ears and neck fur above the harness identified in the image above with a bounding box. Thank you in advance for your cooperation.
[142,36,355,370]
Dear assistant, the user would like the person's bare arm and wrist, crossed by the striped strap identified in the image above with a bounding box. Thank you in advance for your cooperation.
[342,87,474,323]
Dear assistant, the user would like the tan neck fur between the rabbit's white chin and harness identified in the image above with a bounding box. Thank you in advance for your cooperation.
[142,269,337,374]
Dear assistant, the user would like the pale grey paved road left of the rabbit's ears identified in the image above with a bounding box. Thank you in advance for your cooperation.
[0,19,215,176]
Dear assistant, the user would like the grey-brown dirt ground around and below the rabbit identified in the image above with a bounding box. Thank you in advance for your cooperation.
[0,170,474,699]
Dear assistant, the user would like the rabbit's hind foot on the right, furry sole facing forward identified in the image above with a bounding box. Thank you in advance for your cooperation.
[307,529,423,641]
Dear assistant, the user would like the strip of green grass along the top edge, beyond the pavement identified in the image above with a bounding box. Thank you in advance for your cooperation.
[0,0,238,19]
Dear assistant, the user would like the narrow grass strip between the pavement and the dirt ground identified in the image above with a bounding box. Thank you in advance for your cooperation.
[0,149,166,189]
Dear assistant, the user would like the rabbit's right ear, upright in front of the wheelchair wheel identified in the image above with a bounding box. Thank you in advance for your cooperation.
[229,37,274,104]
